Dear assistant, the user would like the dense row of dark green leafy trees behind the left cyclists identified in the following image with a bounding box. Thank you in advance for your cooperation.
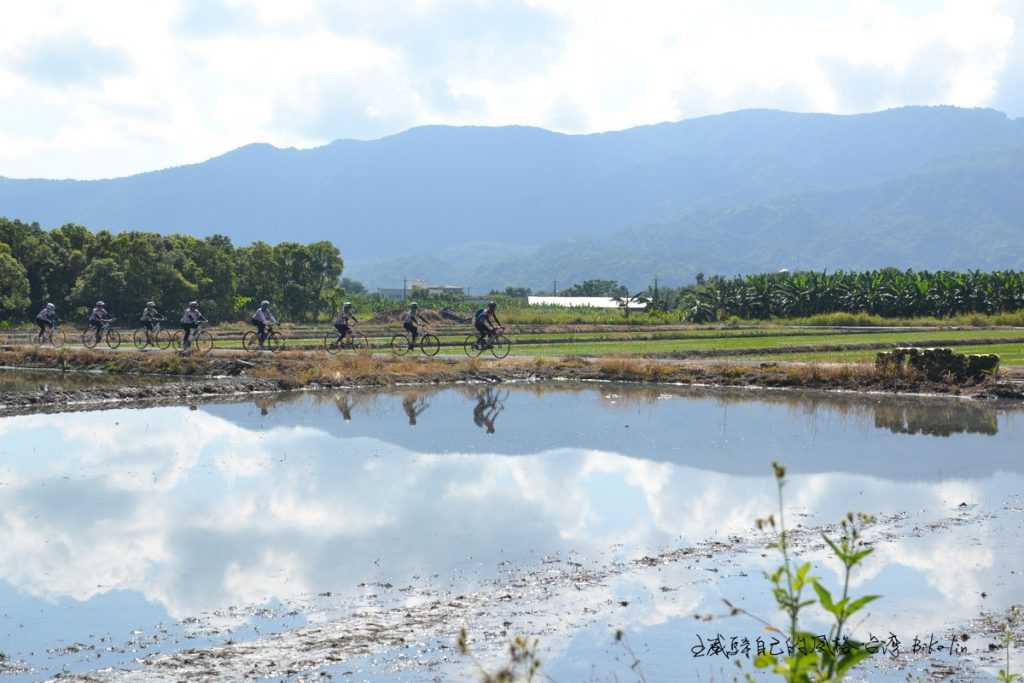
[0,218,344,322]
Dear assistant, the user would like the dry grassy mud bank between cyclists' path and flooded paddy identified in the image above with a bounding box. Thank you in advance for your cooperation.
[0,350,1024,415]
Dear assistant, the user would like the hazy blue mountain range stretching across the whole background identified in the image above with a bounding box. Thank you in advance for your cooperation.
[0,106,1024,290]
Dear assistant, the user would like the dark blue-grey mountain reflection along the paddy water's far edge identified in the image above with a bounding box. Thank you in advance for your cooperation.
[203,384,1022,478]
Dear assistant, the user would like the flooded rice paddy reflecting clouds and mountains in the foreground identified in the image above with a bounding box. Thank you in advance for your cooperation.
[0,384,1024,681]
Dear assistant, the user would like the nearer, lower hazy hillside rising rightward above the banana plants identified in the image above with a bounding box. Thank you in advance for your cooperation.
[372,148,1024,291]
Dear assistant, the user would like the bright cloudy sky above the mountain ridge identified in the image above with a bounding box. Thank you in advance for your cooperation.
[0,0,1024,178]
